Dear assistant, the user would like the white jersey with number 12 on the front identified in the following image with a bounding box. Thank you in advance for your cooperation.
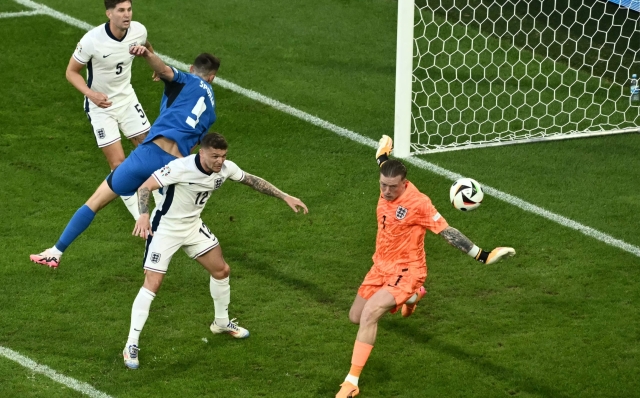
[151,154,244,232]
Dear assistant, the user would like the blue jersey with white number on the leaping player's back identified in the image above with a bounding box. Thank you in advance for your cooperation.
[144,67,216,156]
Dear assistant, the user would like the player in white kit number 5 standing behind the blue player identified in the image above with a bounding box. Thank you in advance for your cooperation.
[66,0,160,218]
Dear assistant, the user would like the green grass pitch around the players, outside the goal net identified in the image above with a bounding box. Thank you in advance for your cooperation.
[0,0,640,398]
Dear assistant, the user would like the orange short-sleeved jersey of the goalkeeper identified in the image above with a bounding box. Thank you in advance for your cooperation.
[373,181,449,273]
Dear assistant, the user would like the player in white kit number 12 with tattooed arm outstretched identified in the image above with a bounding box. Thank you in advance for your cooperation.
[122,133,308,369]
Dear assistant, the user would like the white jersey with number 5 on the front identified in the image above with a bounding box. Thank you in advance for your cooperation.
[73,21,147,111]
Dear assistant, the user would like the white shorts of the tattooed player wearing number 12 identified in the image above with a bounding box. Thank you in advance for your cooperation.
[142,219,220,274]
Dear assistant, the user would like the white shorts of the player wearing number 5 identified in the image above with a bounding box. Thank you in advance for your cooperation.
[85,94,151,148]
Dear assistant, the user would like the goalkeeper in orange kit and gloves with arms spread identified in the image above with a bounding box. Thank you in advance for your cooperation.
[336,135,516,398]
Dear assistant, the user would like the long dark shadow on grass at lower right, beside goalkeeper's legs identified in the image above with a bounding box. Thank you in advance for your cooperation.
[378,319,570,398]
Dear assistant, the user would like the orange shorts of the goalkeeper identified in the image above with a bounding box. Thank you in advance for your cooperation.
[358,265,427,305]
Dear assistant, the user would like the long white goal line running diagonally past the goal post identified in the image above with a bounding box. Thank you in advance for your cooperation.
[8,0,640,257]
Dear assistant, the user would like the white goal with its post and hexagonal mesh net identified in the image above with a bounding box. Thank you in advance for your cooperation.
[394,0,640,157]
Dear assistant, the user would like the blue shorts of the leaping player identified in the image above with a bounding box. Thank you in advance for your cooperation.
[107,142,176,196]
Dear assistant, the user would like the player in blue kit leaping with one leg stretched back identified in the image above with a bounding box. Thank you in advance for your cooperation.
[30,46,220,268]
